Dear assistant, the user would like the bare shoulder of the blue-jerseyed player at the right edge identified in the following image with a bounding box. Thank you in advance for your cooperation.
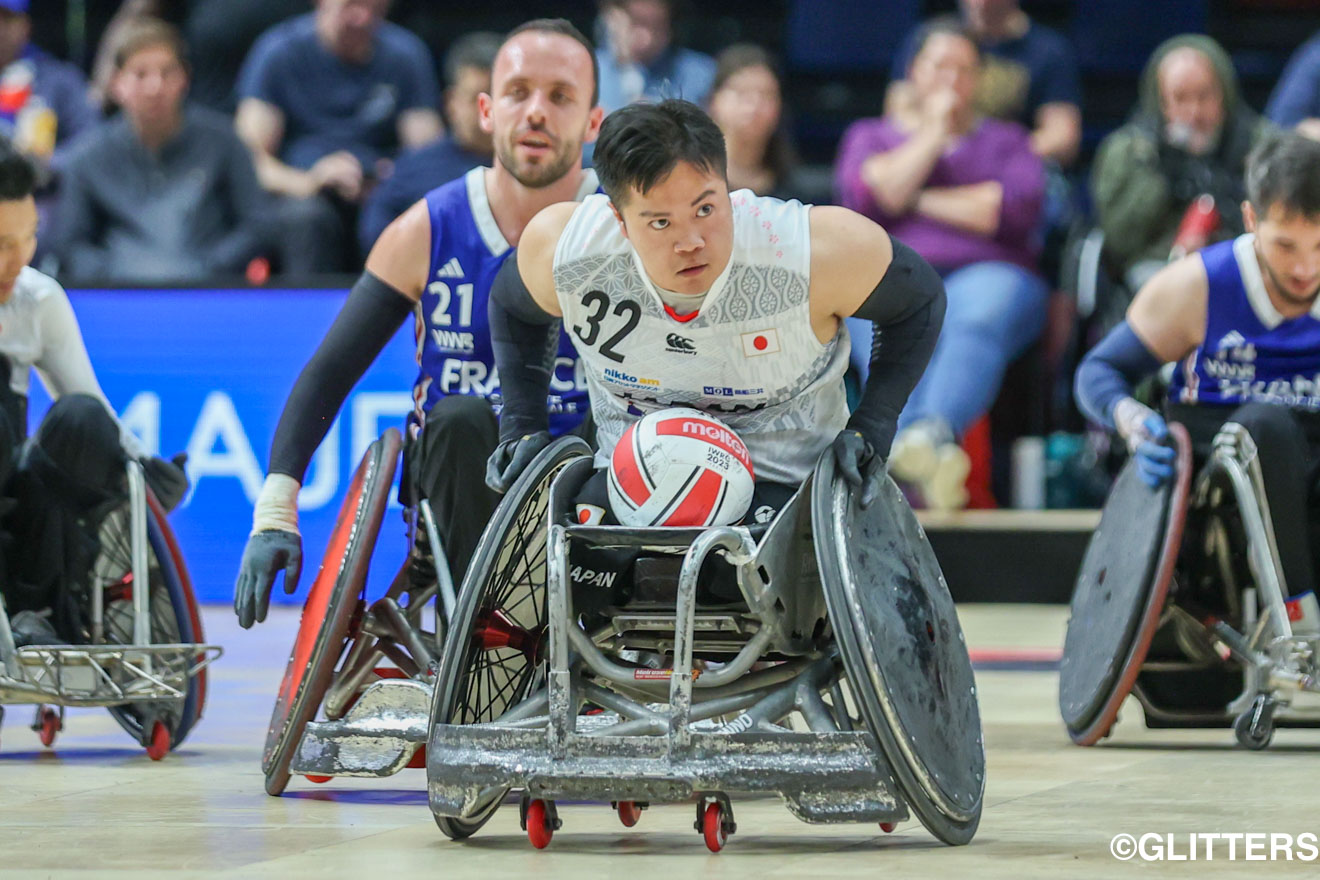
[1127,253,1210,361]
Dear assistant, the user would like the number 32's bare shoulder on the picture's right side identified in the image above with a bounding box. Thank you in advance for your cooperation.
[810,204,894,317]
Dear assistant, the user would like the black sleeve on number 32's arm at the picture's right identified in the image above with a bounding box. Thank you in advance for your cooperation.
[847,239,944,458]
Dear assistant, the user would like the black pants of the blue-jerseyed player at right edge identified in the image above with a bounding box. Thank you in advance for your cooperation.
[1168,404,1320,596]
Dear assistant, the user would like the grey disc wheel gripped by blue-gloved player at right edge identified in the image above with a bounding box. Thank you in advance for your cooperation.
[1059,422,1192,745]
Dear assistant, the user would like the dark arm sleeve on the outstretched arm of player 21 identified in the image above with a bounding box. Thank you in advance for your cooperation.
[271,272,416,483]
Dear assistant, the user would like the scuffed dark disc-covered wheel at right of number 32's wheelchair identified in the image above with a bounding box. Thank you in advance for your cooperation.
[812,451,985,844]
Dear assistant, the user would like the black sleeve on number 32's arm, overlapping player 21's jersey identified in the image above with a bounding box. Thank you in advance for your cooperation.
[487,256,560,441]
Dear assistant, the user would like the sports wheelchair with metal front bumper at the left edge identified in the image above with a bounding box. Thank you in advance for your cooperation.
[0,462,222,761]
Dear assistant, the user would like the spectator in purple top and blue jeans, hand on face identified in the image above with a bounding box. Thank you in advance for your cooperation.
[834,20,1049,509]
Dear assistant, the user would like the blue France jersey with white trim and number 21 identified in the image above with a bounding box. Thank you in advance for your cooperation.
[411,168,598,435]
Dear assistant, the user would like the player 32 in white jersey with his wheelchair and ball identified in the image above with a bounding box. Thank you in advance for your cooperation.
[438,100,985,851]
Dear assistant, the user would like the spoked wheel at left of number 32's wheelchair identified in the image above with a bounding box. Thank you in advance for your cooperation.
[430,437,591,840]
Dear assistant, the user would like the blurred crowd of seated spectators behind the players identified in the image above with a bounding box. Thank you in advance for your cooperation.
[10,0,1320,507]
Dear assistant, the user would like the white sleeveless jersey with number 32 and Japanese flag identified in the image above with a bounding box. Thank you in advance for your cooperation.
[554,190,849,486]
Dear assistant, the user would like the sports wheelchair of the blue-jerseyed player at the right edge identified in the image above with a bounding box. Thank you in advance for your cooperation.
[1059,422,1320,749]
